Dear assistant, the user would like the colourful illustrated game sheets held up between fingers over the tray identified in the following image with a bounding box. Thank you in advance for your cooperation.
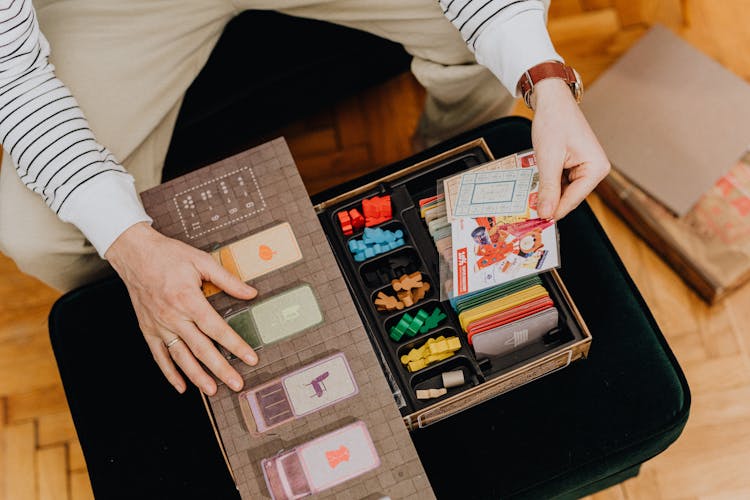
[442,152,559,297]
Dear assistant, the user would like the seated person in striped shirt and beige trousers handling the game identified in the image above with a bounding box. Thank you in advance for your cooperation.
[0,0,609,394]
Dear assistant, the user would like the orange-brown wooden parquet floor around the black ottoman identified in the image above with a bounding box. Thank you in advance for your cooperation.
[0,0,750,500]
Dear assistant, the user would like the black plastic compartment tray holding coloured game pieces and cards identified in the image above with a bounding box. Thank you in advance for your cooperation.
[318,147,583,417]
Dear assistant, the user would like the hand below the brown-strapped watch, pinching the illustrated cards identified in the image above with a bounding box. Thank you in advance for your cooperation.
[531,78,610,220]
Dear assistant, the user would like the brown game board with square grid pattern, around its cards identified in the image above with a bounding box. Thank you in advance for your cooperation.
[141,138,433,499]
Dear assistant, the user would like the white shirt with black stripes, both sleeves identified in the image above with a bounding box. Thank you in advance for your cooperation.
[0,0,560,256]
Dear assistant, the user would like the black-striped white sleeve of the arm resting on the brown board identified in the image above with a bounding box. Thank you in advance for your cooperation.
[0,0,151,256]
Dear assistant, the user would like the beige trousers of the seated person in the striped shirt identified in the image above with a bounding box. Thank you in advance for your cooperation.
[0,0,512,290]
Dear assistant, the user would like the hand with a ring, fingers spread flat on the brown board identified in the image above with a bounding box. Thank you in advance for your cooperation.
[106,222,258,395]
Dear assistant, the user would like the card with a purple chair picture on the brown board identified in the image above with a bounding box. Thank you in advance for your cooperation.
[239,353,359,434]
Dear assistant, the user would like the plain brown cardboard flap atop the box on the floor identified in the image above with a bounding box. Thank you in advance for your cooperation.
[581,25,750,216]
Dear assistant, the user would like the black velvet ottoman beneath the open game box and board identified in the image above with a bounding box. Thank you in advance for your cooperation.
[50,118,690,499]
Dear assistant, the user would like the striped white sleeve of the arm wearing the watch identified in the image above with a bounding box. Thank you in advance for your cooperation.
[439,0,563,96]
